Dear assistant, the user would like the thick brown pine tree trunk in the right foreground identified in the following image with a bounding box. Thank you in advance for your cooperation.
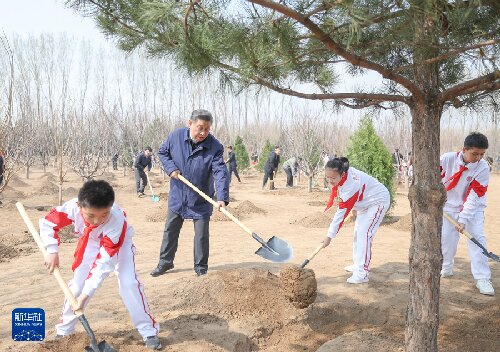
[406,96,446,352]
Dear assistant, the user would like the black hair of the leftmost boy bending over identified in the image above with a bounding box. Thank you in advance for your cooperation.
[78,180,115,209]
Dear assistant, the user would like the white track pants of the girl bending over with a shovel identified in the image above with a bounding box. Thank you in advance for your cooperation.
[352,203,389,279]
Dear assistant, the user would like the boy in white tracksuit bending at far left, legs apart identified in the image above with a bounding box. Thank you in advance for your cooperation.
[39,181,161,349]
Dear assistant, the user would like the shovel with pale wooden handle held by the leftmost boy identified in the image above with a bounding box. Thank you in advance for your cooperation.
[16,202,116,352]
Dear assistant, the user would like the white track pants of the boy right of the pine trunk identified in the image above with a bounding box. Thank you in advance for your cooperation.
[441,211,491,280]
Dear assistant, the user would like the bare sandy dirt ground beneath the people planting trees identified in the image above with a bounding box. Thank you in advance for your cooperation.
[0,169,500,352]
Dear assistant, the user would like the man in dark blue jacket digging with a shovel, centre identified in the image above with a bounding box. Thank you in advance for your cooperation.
[151,110,229,276]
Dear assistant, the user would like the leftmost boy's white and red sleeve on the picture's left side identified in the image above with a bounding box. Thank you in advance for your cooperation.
[38,200,78,254]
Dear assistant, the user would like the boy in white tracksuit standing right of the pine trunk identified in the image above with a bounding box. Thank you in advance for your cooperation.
[440,132,495,295]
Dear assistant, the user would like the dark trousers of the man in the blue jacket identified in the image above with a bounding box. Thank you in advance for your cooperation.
[159,209,210,273]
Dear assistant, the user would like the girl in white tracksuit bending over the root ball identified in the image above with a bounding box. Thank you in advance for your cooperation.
[323,158,390,284]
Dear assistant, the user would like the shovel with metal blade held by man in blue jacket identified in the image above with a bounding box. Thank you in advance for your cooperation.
[178,174,293,263]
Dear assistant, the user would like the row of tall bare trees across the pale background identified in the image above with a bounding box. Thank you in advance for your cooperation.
[0,35,500,187]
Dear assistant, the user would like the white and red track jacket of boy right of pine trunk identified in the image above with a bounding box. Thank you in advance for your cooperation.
[440,152,490,224]
